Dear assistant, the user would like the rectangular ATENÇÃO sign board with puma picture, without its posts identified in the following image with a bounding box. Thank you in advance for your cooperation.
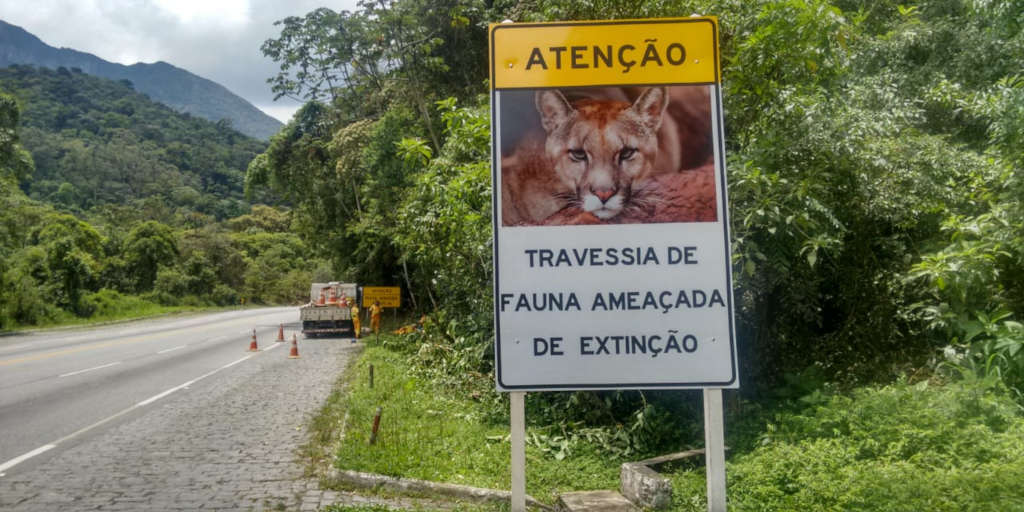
[489,17,739,391]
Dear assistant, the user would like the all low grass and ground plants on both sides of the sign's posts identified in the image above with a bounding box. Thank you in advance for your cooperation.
[310,329,1024,512]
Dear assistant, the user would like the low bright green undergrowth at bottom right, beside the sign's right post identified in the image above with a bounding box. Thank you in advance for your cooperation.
[673,381,1024,512]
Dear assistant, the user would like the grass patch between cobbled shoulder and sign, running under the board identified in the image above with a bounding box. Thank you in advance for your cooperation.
[306,336,623,502]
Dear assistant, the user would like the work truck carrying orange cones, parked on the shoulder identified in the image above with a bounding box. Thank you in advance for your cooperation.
[299,281,359,338]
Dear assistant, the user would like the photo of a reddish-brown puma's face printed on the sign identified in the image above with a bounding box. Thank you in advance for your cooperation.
[499,85,717,226]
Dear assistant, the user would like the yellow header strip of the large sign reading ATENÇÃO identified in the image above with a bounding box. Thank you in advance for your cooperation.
[490,16,720,89]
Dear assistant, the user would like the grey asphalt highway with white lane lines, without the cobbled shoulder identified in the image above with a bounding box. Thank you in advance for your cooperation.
[0,307,301,476]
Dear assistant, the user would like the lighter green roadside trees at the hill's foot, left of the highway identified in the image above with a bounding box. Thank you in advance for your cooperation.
[0,189,327,329]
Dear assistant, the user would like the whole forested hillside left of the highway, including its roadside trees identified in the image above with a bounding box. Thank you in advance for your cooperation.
[0,67,327,329]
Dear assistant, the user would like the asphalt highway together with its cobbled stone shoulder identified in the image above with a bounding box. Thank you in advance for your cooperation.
[0,308,403,511]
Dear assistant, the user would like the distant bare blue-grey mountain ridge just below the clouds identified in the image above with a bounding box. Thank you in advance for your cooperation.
[0,20,282,140]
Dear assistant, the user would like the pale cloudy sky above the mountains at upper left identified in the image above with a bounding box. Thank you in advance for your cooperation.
[0,0,355,122]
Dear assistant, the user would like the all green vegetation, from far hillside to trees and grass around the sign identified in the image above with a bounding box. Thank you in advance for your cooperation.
[0,0,1024,510]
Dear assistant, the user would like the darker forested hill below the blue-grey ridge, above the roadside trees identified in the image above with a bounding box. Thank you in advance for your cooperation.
[0,65,266,219]
